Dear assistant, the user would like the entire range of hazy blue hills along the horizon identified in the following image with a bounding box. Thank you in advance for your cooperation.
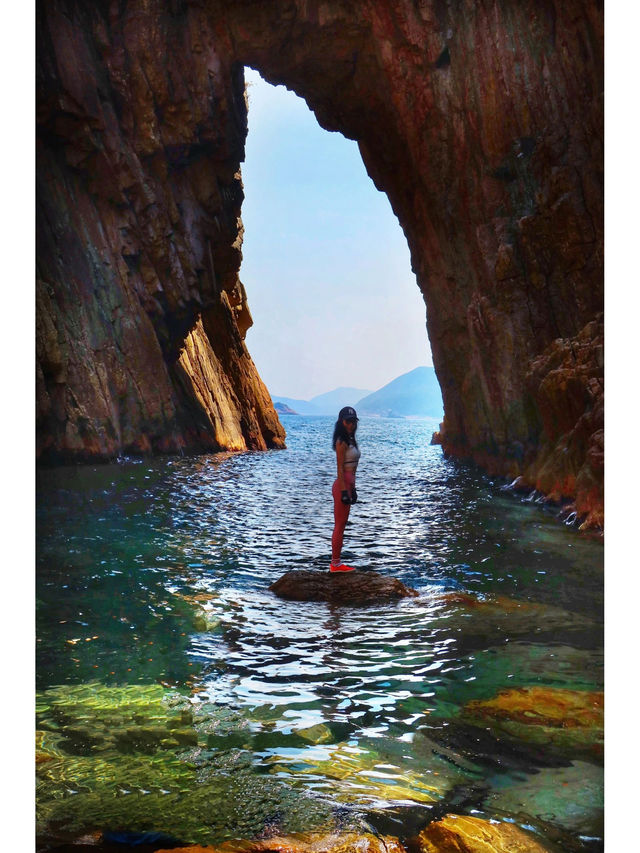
[273,367,443,418]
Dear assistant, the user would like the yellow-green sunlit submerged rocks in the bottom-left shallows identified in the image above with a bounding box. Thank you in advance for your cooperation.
[37,682,332,843]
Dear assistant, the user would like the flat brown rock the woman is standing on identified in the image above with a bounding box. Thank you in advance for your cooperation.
[269,570,418,603]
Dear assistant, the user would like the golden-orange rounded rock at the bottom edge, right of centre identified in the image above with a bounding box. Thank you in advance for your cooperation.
[409,814,549,853]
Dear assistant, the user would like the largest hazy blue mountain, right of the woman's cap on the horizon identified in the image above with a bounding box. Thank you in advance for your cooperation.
[354,367,443,418]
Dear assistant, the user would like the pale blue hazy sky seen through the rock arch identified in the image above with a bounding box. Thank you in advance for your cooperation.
[240,68,433,399]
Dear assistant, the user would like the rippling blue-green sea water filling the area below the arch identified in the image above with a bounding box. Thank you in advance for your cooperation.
[37,416,603,850]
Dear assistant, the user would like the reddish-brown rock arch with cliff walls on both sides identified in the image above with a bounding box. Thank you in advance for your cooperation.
[39,0,603,525]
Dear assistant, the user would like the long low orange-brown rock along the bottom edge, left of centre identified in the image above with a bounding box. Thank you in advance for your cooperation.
[156,832,406,853]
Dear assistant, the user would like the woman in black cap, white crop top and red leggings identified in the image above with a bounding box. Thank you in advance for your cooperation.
[329,406,360,572]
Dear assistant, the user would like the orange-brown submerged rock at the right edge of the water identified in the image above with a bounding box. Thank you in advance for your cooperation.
[462,687,604,757]
